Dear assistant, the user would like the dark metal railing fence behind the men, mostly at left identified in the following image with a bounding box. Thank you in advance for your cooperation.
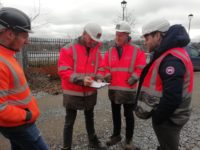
[17,37,143,68]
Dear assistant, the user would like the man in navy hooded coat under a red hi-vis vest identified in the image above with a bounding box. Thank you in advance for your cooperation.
[136,18,193,150]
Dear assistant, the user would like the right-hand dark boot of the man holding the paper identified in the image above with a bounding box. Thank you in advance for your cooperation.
[88,135,106,150]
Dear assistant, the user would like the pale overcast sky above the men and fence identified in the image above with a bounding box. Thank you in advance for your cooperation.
[0,0,200,42]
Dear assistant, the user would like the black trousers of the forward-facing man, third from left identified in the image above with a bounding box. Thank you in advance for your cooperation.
[111,101,134,140]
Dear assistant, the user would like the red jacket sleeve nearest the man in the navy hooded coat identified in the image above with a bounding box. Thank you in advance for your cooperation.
[131,48,146,80]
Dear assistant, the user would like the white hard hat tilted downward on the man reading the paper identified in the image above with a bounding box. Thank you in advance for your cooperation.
[84,23,102,42]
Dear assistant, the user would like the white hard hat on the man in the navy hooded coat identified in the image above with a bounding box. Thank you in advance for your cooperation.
[142,18,170,35]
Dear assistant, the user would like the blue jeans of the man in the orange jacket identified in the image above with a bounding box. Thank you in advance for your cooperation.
[0,124,49,150]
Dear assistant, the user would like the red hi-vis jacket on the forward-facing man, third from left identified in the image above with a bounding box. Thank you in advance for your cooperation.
[104,43,146,91]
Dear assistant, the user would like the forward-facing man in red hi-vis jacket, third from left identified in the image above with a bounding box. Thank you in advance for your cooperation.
[104,21,146,150]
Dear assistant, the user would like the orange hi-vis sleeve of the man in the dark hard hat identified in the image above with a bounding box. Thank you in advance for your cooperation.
[0,63,26,125]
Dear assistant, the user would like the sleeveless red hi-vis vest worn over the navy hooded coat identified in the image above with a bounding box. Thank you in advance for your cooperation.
[138,48,193,124]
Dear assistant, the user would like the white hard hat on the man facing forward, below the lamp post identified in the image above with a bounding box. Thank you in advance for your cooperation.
[115,21,131,33]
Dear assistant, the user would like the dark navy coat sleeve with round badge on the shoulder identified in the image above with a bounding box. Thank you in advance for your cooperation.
[152,55,186,124]
